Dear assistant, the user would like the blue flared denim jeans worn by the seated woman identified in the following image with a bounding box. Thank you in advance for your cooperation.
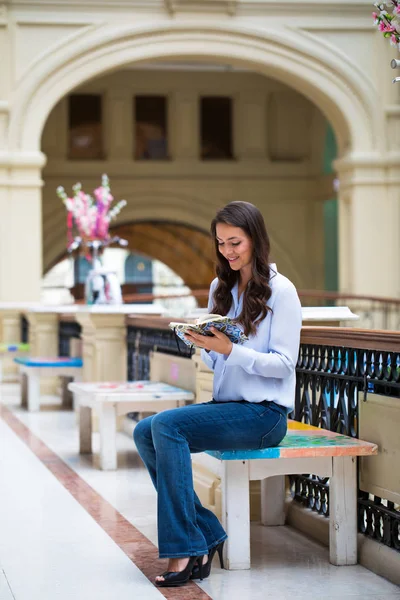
[133,400,287,558]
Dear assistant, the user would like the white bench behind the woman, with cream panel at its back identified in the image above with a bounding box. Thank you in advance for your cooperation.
[68,352,196,470]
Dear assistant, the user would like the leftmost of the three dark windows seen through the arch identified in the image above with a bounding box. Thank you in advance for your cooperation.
[69,94,104,160]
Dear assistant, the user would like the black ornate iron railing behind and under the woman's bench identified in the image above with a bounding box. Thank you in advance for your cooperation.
[291,334,400,551]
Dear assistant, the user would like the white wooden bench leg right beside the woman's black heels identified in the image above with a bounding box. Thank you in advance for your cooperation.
[221,460,250,569]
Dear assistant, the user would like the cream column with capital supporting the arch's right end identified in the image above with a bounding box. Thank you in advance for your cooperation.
[336,155,400,298]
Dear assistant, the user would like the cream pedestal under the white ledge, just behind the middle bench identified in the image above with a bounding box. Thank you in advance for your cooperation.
[76,309,127,381]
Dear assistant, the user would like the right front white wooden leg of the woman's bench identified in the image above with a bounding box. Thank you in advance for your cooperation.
[329,456,357,566]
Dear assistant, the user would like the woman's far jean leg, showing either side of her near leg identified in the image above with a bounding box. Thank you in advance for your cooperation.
[133,416,227,553]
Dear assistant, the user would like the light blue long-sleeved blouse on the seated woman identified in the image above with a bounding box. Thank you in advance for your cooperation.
[201,264,302,410]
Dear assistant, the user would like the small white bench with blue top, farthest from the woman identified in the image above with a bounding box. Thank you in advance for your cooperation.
[14,356,83,411]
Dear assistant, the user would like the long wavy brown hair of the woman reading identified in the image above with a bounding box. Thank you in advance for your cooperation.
[211,202,272,335]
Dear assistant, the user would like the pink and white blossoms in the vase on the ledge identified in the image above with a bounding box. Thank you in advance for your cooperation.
[57,175,126,252]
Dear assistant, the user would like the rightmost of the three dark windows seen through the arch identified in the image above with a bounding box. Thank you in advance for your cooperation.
[200,96,233,160]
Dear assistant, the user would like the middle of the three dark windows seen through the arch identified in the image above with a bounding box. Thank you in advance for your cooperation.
[134,96,168,160]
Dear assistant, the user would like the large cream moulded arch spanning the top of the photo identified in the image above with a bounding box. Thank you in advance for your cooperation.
[9,21,383,154]
